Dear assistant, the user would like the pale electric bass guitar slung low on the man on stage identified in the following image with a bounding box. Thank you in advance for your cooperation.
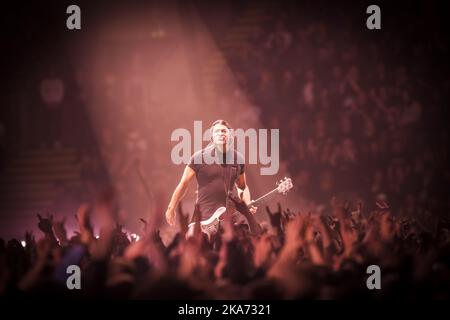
[186,178,293,237]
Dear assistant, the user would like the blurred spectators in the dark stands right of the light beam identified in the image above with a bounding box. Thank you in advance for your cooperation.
[215,1,449,220]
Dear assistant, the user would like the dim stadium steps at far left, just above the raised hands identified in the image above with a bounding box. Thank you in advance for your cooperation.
[0,148,81,236]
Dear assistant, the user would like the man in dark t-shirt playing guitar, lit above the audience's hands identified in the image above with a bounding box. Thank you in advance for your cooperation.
[166,120,257,225]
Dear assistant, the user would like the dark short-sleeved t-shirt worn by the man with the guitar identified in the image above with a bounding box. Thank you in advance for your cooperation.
[188,146,248,220]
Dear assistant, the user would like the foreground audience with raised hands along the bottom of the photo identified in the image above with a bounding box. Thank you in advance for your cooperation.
[0,191,450,300]
